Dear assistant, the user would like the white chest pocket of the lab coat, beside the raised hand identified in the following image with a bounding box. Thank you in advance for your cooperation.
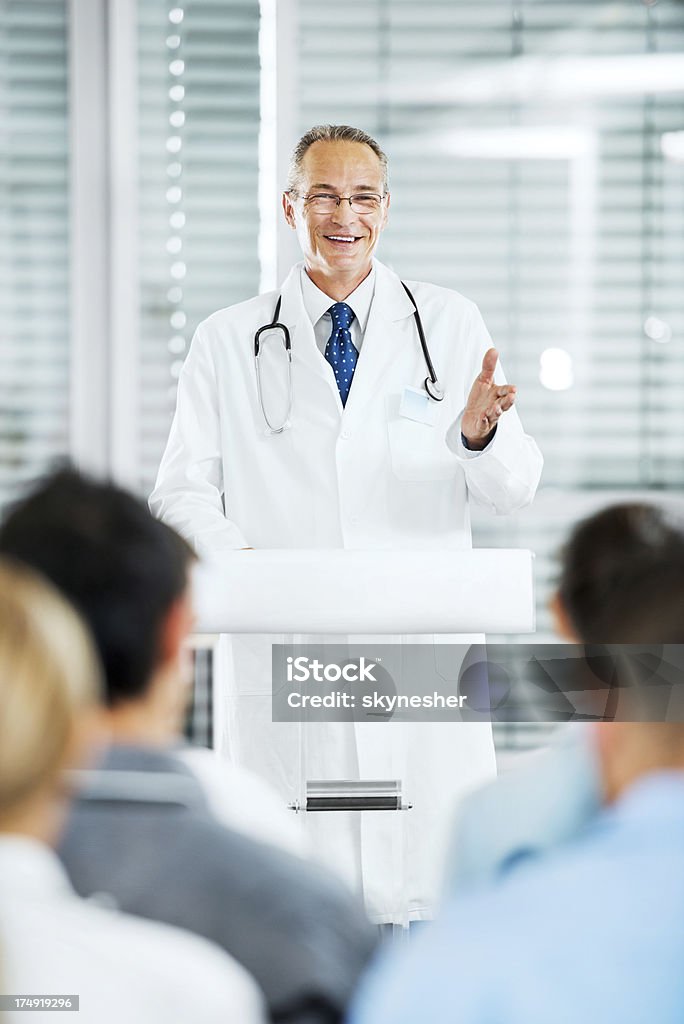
[387,394,460,480]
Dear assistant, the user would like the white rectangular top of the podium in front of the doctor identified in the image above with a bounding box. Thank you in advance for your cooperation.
[195,548,535,634]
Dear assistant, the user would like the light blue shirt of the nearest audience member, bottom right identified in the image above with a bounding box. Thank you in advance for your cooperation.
[350,772,684,1024]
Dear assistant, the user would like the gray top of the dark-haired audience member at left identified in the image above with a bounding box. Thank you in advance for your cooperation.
[58,746,375,1024]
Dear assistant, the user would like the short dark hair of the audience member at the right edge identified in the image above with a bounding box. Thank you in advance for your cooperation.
[558,503,684,644]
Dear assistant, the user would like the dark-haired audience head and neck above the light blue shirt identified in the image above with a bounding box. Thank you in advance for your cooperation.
[554,504,684,800]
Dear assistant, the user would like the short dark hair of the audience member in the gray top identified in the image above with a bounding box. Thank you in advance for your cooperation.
[0,468,195,706]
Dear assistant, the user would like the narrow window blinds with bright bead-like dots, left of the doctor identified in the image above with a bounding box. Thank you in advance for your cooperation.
[138,0,259,493]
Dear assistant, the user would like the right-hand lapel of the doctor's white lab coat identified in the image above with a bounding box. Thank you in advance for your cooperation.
[345,260,414,418]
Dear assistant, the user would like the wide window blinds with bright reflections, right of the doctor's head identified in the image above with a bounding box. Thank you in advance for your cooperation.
[297,0,684,741]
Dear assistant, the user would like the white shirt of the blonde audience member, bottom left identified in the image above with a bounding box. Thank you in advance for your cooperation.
[0,835,264,1024]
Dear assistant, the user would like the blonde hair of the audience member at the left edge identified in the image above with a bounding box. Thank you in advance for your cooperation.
[0,559,100,822]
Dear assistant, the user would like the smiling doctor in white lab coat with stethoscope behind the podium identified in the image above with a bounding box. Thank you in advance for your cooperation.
[151,126,542,921]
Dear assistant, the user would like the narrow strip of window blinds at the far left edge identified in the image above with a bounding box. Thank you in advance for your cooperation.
[0,0,70,506]
